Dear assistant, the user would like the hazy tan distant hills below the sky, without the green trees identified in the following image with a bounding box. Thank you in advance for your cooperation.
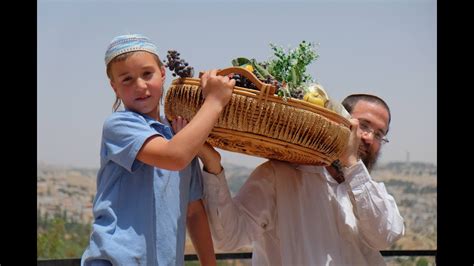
[37,162,437,249]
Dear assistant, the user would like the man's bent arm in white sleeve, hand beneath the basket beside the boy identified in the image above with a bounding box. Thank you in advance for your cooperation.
[198,144,275,251]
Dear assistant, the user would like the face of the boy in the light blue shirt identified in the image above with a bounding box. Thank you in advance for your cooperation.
[110,51,165,120]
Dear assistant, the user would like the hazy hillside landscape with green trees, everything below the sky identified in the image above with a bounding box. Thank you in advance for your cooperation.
[37,159,437,265]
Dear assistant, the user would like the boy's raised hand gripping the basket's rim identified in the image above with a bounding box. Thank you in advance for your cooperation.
[201,69,235,107]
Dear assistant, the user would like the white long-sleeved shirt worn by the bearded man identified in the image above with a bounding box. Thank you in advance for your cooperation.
[203,160,405,265]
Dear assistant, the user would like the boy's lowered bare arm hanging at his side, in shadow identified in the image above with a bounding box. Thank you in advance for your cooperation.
[186,199,216,265]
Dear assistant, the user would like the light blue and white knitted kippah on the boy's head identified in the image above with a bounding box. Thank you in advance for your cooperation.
[105,34,159,65]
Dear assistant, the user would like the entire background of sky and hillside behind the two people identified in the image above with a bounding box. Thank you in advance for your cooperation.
[36,0,438,265]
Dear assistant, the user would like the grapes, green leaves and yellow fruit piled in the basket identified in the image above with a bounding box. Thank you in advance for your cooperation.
[165,41,349,118]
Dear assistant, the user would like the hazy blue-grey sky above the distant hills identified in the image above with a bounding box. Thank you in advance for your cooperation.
[37,0,437,168]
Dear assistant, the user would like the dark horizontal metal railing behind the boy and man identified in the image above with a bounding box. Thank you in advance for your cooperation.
[37,250,437,266]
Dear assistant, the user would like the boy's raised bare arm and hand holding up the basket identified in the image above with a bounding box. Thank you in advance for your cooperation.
[137,70,235,170]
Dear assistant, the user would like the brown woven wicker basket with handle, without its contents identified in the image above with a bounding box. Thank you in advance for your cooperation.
[164,67,350,165]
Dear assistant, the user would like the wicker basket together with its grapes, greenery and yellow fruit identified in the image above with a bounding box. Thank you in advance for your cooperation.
[164,42,350,165]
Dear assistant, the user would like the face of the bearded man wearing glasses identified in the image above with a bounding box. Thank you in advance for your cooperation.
[351,100,389,170]
